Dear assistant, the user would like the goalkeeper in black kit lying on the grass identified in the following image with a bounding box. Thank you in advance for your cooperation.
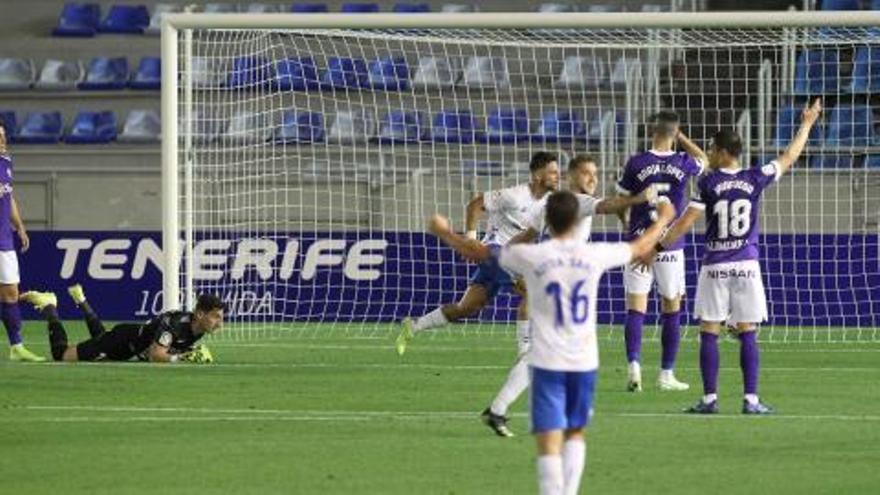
[21,284,225,363]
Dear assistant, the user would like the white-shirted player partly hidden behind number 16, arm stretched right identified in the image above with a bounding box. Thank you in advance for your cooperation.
[481,154,657,437]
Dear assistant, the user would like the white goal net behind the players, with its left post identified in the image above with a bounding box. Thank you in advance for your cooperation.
[163,16,880,342]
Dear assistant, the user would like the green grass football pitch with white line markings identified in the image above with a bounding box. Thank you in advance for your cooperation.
[0,323,880,495]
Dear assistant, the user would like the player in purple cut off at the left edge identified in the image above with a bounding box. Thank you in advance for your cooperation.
[0,120,46,362]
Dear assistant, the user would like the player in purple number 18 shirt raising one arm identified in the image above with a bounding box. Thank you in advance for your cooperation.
[658,99,822,414]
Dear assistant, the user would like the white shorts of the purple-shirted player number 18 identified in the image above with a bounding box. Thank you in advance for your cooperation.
[694,260,767,325]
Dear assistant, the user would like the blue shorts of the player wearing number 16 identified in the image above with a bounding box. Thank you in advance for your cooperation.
[531,367,596,433]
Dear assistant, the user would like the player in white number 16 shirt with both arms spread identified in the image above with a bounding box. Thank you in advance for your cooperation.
[429,191,675,495]
